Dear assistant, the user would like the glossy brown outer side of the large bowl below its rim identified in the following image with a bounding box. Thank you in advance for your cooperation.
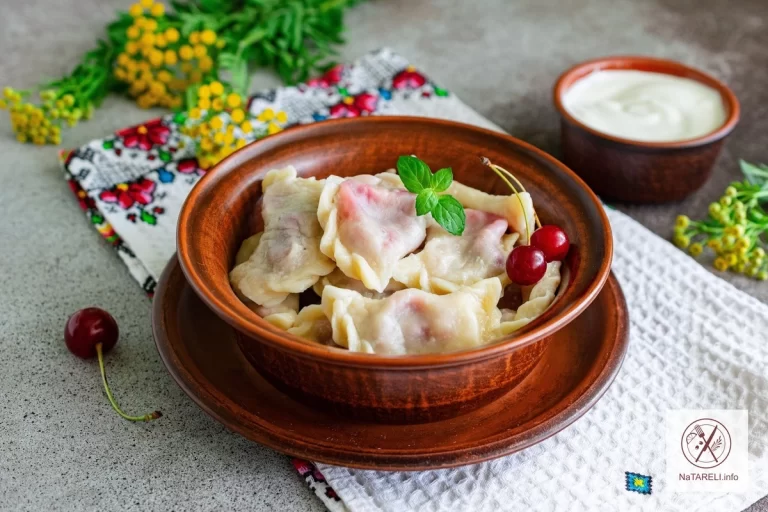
[237,334,550,423]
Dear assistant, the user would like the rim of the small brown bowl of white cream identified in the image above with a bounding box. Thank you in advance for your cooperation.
[552,55,741,149]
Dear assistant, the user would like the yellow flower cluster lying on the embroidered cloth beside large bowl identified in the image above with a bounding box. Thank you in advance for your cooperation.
[182,81,288,169]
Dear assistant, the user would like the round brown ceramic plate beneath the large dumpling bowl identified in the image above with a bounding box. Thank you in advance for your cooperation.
[152,257,629,470]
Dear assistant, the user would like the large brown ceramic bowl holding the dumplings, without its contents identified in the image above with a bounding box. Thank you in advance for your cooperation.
[178,117,613,423]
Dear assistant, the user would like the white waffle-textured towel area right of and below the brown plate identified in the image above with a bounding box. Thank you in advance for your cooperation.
[318,206,768,512]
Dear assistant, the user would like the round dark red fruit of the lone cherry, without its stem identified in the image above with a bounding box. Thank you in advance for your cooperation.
[64,308,120,359]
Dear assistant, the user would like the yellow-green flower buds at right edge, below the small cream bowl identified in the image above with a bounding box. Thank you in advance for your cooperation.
[673,215,768,281]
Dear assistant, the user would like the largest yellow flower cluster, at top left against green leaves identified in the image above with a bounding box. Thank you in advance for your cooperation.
[114,0,224,108]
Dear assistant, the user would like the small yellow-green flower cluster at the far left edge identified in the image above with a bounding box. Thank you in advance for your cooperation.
[0,87,92,144]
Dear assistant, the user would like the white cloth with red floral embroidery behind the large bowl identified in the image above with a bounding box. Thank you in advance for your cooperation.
[62,49,495,294]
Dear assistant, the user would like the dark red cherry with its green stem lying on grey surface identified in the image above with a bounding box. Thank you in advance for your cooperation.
[64,308,163,421]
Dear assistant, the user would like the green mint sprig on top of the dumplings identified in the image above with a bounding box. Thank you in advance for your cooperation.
[397,155,467,236]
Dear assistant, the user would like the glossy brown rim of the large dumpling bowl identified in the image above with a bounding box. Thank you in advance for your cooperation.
[176,116,613,369]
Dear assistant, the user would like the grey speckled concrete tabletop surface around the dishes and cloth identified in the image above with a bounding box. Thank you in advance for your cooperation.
[0,0,768,512]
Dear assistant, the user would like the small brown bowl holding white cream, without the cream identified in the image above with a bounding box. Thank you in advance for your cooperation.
[554,56,739,203]
